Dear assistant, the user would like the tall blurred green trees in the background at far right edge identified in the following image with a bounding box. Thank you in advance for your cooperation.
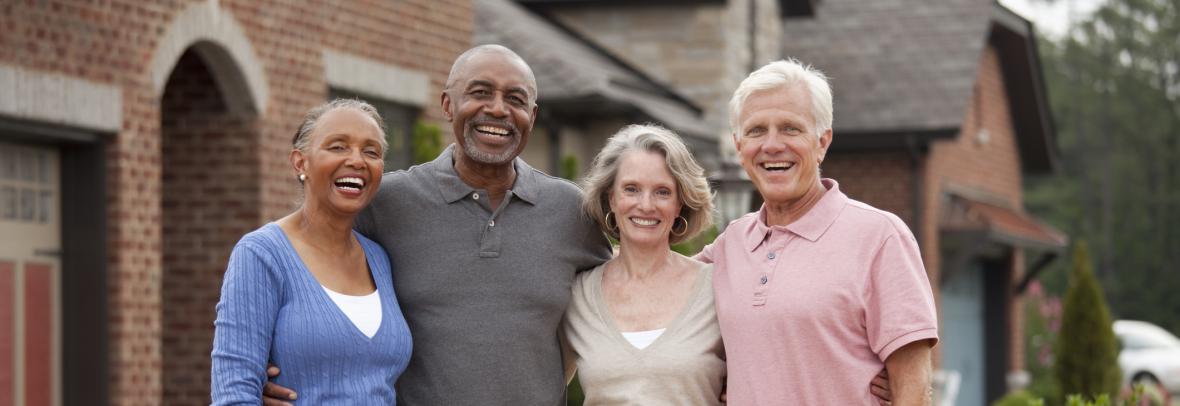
[1025,0,1180,332]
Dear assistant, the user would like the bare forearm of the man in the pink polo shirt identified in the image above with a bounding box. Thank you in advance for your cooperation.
[885,340,933,406]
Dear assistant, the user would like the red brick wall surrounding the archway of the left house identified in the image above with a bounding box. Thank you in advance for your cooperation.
[0,0,472,405]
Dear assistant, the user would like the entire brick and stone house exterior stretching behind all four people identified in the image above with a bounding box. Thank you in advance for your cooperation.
[0,0,1066,405]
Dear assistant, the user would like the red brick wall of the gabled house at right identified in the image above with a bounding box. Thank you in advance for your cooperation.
[824,47,1024,371]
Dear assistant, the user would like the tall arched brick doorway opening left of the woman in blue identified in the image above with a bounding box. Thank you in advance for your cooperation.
[160,42,261,405]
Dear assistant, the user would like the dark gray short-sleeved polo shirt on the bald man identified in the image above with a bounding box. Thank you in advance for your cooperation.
[356,145,610,406]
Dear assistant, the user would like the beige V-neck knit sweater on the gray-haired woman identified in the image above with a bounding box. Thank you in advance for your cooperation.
[562,266,726,405]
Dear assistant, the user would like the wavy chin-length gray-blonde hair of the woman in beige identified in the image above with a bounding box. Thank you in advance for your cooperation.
[582,124,713,244]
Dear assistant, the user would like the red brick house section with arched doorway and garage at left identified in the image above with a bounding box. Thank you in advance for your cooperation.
[0,0,473,406]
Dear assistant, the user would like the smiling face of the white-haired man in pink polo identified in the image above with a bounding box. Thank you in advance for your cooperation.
[733,83,832,205]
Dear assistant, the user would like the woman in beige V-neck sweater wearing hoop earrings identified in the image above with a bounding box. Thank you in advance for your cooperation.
[563,125,726,405]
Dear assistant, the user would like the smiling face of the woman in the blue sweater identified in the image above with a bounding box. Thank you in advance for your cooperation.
[291,107,385,215]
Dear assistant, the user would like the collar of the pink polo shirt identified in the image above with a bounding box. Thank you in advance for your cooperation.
[745,178,848,251]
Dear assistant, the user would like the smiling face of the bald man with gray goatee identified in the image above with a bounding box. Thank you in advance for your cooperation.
[443,51,537,165]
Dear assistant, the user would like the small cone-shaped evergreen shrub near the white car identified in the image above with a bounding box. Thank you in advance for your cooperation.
[1054,241,1121,399]
